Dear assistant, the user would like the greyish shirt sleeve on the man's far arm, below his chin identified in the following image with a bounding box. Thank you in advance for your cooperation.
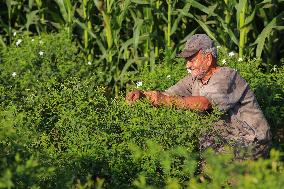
[164,76,193,96]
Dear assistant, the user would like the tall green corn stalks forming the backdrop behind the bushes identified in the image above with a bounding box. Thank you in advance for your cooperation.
[0,0,284,91]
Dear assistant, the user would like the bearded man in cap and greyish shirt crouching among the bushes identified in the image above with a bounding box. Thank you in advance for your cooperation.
[126,34,271,159]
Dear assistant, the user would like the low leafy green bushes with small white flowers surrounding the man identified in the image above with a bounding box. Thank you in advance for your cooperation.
[0,30,284,188]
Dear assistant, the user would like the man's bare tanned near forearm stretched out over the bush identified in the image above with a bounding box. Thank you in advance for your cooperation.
[143,91,211,110]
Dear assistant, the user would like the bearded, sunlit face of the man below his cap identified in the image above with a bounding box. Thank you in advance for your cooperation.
[186,51,210,79]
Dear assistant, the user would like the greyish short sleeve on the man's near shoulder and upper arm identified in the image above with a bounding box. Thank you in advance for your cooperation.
[203,70,249,112]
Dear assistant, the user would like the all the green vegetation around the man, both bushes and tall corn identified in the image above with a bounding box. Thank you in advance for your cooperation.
[0,0,284,189]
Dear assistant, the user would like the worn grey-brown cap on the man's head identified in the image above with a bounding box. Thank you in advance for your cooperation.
[178,34,215,58]
